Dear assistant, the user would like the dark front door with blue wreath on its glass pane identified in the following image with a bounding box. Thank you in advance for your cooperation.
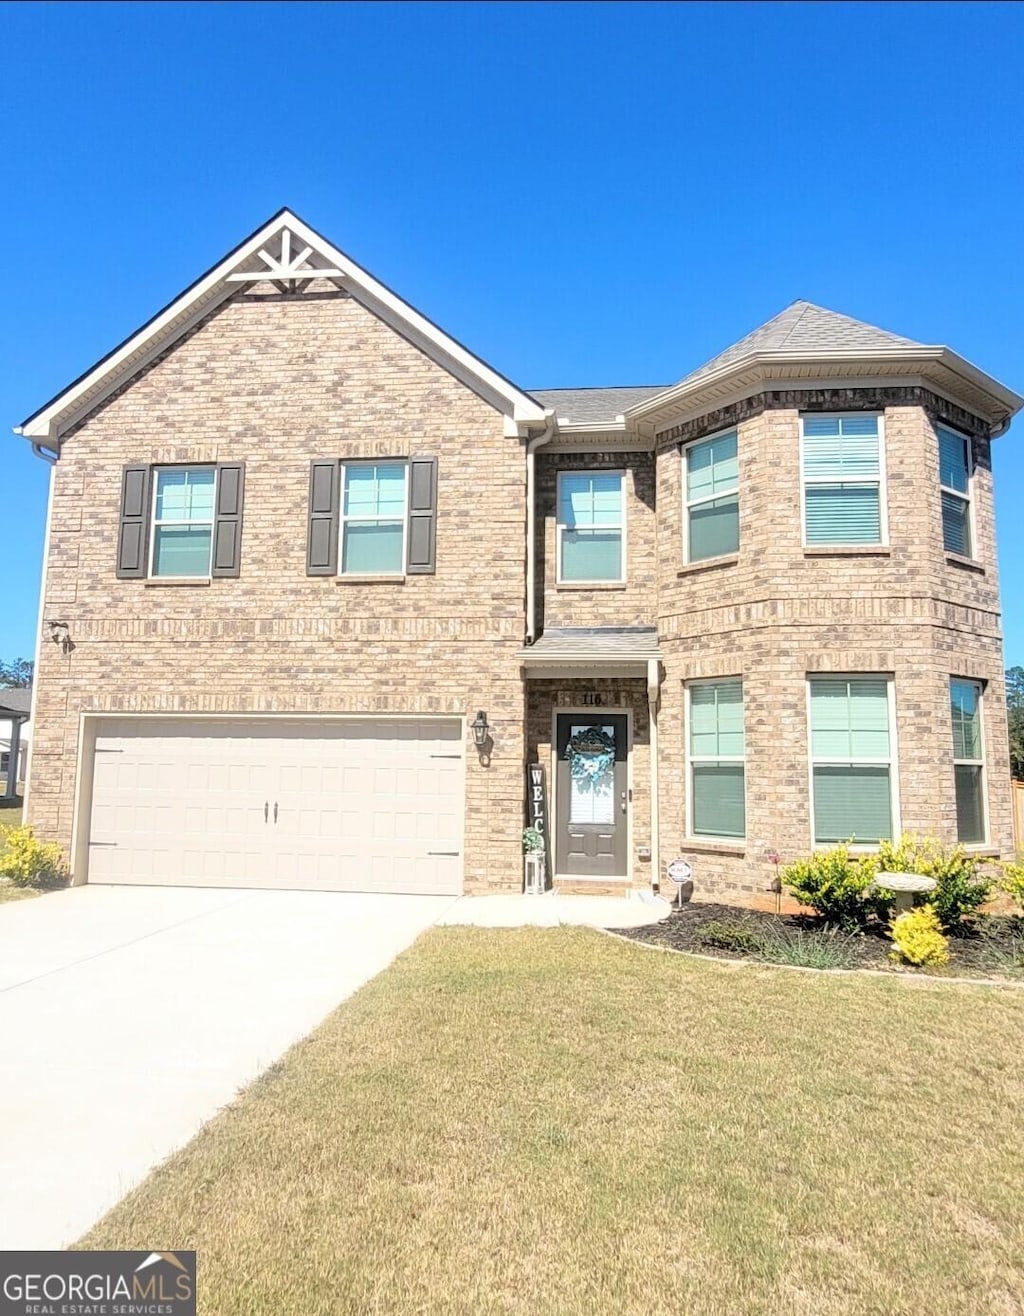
[554,713,629,878]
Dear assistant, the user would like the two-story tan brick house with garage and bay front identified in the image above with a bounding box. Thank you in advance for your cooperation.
[12,211,1021,898]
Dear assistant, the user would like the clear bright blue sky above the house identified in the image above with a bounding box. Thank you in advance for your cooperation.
[0,3,1024,663]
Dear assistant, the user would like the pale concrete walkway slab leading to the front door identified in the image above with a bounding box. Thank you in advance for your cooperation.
[437,891,671,928]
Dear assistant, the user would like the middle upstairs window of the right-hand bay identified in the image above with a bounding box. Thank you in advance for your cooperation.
[800,416,884,545]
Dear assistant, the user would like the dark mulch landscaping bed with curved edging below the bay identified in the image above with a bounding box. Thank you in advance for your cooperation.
[619,901,1024,982]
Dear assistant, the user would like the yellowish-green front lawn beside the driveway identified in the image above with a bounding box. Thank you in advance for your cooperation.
[82,928,1024,1316]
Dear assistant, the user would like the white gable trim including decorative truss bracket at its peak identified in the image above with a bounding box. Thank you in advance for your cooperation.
[14,209,545,445]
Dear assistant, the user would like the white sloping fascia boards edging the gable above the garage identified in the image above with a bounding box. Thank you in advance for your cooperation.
[16,211,545,440]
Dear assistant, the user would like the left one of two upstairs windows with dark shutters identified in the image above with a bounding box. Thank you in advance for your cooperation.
[117,462,245,580]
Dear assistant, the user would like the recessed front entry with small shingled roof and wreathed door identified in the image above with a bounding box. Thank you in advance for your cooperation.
[520,626,661,894]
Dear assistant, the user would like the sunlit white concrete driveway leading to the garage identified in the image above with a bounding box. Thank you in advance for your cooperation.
[0,886,454,1249]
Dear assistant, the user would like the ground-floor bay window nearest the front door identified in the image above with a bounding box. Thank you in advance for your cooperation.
[687,679,746,840]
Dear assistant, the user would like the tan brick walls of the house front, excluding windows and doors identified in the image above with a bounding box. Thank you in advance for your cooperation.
[29,284,1012,900]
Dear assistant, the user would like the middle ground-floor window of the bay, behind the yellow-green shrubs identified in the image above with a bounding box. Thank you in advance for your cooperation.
[808,676,894,845]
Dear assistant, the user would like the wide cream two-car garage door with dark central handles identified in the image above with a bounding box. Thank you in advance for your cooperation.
[88,719,463,895]
